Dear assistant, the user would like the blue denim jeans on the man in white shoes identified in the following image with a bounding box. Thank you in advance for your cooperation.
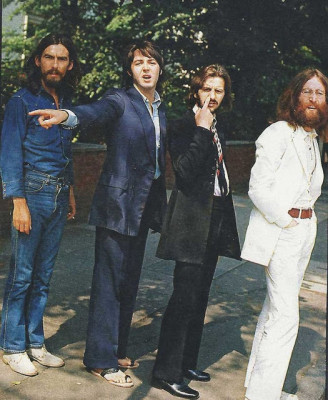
[0,171,69,353]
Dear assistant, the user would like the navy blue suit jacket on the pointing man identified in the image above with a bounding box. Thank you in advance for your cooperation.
[72,87,166,236]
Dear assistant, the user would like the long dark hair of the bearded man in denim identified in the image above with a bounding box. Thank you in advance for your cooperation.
[25,33,81,93]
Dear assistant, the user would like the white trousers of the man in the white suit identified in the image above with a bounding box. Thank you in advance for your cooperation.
[245,215,317,400]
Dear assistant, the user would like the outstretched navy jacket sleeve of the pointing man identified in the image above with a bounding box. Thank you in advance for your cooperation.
[71,89,124,130]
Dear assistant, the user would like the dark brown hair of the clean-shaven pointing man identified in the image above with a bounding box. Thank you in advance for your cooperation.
[123,40,164,91]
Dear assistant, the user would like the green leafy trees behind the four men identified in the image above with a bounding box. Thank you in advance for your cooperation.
[2,0,328,142]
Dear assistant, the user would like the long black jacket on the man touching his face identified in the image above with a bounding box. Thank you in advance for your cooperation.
[157,111,240,264]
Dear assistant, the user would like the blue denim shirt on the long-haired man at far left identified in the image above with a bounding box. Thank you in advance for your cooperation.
[0,88,73,198]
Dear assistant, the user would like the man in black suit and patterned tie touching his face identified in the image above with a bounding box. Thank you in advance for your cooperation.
[152,65,240,399]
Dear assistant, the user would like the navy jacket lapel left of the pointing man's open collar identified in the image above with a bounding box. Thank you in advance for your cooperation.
[126,87,156,164]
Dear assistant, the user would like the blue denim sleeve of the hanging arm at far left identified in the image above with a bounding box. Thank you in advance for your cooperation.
[0,96,27,198]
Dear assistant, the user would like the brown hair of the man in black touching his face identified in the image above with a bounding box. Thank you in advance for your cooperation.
[188,64,232,111]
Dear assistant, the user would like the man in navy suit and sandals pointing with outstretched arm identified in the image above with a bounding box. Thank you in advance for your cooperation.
[33,41,166,387]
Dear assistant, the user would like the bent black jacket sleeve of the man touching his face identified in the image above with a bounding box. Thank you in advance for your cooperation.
[168,120,213,188]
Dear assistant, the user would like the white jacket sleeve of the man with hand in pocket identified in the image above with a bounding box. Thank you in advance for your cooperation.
[248,123,292,228]
